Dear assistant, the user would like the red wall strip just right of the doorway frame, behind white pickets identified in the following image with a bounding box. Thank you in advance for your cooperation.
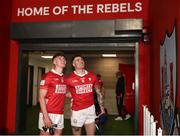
[138,41,152,135]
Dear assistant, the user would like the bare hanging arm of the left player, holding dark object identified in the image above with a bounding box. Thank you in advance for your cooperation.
[39,89,52,128]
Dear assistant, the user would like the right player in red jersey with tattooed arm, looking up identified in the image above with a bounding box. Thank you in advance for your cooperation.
[66,55,104,135]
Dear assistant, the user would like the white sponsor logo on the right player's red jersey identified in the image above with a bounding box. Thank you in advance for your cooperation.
[75,84,93,94]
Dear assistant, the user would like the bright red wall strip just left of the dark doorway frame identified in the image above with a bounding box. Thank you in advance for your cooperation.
[6,41,19,134]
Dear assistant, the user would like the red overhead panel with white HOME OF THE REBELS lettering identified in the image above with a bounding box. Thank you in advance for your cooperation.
[12,0,148,22]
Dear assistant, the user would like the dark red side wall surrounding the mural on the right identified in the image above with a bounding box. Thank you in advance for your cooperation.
[149,0,180,126]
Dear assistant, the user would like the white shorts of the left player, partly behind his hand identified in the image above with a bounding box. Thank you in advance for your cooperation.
[39,112,64,130]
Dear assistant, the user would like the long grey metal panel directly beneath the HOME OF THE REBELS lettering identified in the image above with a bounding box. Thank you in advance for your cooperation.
[11,19,143,40]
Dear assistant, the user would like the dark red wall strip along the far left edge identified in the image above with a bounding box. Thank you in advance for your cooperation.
[0,0,11,134]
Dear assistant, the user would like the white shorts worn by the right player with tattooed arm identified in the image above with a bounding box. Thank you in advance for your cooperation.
[71,105,96,127]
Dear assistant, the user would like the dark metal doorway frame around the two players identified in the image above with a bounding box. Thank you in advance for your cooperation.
[16,36,141,135]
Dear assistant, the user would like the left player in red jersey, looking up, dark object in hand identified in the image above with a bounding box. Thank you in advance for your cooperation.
[39,54,67,135]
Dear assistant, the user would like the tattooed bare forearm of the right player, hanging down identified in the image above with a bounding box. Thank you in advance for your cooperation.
[95,85,105,113]
